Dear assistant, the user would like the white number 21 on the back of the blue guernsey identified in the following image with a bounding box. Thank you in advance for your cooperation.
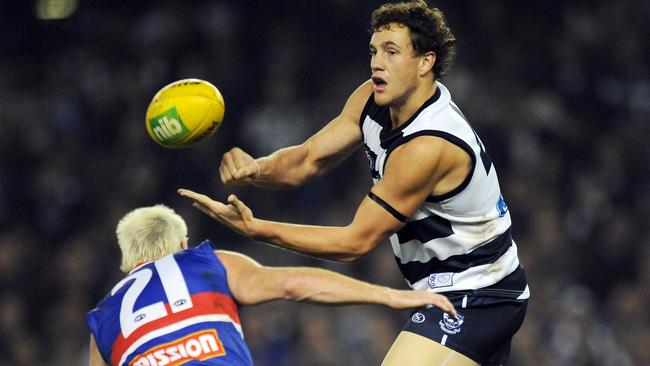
[111,255,193,338]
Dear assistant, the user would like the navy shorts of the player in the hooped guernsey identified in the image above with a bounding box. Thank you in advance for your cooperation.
[403,293,528,366]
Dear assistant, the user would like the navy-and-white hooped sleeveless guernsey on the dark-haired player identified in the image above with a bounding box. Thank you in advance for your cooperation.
[360,82,529,299]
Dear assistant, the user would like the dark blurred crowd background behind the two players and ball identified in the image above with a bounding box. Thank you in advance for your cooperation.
[0,0,650,366]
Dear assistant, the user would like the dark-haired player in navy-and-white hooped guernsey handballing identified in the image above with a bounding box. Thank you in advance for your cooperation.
[180,0,529,366]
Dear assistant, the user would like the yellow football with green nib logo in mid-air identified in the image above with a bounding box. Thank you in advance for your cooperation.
[145,79,226,148]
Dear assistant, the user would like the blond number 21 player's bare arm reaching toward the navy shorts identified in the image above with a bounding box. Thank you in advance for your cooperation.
[216,250,456,316]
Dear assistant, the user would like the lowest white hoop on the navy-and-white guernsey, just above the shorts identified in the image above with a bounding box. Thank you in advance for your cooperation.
[407,242,519,292]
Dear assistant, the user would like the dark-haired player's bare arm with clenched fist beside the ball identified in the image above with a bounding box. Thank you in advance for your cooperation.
[219,81,372,188]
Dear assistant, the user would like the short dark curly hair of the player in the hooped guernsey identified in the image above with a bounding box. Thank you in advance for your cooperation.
[370,0,456,78]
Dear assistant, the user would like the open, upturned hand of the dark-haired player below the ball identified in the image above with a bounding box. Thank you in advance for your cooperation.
[178,188,253,236]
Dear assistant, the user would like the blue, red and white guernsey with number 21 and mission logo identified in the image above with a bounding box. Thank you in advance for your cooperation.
[87,240,253,366]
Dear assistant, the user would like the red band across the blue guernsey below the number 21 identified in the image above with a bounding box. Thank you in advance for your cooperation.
[111,292,241,365]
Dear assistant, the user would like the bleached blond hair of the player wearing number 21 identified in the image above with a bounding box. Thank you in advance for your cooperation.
[115,204,187,273]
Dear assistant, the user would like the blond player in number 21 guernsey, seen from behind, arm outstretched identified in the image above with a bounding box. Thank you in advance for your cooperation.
[87,205,455,366]
